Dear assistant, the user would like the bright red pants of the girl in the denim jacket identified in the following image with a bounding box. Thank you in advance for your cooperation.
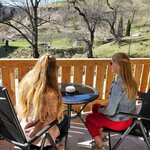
[86,104,132,138]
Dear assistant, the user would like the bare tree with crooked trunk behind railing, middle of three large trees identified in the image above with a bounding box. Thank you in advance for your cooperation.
[67,0,102,58]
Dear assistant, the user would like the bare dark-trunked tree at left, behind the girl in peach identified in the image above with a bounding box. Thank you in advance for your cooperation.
[0,0,51,58]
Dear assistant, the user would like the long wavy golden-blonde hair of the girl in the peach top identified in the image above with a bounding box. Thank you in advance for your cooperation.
[17,54,62,121]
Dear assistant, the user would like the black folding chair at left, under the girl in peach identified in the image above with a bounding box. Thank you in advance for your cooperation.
[0,87,58,150]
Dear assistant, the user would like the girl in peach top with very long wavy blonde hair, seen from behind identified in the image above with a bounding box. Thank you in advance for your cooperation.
[17,54,67,149]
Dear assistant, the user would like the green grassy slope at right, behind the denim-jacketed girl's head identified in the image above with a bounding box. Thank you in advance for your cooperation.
[94,22,150,58]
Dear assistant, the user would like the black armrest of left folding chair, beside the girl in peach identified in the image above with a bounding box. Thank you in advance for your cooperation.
[28,120,58,144]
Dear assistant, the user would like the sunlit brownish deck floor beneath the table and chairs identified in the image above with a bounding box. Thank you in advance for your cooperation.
[0,119,148,150]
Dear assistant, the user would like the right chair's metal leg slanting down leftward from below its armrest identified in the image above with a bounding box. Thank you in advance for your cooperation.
[112,120,138,150]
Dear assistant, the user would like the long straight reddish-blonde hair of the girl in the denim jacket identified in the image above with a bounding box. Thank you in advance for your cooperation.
[112,52,138,100]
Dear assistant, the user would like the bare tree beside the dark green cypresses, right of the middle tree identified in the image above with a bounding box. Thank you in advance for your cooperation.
[103,0,135,44]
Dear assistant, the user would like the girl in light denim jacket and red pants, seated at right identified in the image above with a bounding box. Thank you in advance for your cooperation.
[86,53,138,149]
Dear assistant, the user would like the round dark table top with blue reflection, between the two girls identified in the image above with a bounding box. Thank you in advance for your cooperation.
[58,83,99,105]
